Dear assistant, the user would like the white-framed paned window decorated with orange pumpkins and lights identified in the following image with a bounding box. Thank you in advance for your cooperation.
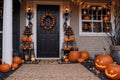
[79,4,112,36]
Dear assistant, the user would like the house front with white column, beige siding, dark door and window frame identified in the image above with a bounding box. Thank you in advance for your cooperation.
[0,0,119,64]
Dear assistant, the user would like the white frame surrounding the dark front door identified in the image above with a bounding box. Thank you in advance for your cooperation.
[32,1,64,59]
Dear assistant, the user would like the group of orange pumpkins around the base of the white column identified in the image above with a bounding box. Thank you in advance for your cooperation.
[0,56,24,73]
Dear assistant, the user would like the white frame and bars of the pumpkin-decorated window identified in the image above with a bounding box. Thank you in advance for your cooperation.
[79,2,114,36]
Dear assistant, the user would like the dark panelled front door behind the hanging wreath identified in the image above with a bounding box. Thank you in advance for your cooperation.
[37,5,60,58]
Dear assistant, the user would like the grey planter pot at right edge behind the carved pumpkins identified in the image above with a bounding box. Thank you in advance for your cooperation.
[110,46,120,64]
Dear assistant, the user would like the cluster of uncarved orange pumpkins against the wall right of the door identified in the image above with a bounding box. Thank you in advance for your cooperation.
[64,51,89,63]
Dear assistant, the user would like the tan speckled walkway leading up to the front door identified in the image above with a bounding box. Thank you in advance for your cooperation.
[6,64,100,80]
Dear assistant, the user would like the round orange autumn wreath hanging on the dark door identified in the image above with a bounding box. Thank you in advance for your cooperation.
[40,13,56,30]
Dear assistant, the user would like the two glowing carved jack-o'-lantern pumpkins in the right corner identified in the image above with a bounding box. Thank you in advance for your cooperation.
[95,55,120,80]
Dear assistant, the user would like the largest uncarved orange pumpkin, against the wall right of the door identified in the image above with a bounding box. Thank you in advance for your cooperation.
[69,51,80,62]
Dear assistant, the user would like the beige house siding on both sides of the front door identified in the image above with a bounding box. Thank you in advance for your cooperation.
[20,0,114,58]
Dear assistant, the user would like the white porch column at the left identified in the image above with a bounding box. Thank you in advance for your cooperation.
[2,0,12,65]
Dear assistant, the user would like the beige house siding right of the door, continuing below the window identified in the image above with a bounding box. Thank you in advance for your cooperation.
[71,4,110,58]
